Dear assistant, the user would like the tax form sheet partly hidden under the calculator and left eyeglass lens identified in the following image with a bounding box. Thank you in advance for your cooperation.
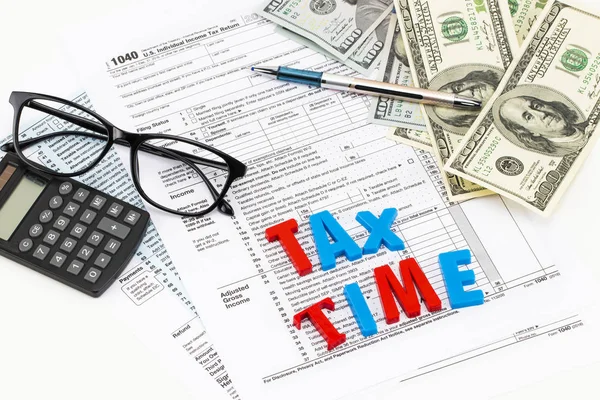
[0,93,239,399]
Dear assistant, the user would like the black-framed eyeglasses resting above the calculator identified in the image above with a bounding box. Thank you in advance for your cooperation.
[1,92,246,217]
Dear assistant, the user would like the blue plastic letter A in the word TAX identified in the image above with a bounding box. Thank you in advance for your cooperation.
[309,211,362,271]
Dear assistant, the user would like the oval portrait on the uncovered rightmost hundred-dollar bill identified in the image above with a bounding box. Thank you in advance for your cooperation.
[493,85,589,156]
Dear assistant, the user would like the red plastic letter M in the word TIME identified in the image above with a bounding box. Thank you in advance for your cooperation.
[375,258,442,324]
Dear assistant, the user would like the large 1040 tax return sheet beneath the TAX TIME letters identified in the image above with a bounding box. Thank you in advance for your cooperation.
[76,7,593,399]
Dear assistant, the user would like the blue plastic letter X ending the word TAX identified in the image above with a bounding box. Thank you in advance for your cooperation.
[356,208,404,254]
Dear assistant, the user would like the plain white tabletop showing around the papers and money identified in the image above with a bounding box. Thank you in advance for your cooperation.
[0,0,600,400]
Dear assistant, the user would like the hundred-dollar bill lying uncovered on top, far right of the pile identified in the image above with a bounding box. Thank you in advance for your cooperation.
[446,1,600,215]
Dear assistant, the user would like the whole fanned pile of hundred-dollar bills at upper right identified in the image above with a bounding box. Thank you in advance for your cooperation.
[261,0,600,215]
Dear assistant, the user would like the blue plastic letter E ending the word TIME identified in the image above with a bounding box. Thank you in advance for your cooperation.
[439,250,483,308]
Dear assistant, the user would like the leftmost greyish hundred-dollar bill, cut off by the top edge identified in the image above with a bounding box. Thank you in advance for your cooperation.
[259,0,393,60]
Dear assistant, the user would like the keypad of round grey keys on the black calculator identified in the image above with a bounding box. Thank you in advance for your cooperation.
[11,177,148,295]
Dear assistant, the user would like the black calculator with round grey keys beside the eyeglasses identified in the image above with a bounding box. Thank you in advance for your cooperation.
[0,152,150,297]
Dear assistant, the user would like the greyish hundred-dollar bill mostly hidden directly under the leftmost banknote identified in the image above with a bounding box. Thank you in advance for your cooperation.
[276,13,391,76]
